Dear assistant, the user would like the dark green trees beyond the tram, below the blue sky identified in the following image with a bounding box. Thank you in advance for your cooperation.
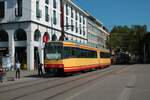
[107,25,147,56]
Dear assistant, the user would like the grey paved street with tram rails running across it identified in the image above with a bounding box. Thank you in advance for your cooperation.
[0,64,150,100]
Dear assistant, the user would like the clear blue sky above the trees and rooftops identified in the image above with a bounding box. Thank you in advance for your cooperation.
[73,0,150,31]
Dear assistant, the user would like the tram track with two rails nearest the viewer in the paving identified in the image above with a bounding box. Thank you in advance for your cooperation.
[11,67,131,100]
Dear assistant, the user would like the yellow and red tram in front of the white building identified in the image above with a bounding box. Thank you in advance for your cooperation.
[44,41,111,74]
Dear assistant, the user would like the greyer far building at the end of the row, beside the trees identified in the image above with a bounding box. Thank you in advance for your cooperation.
[87,14,109,48]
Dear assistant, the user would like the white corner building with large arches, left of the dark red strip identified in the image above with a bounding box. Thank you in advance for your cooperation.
[0,0,61,69]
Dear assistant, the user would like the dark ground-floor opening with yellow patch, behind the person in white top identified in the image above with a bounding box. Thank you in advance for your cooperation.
[15,47,27,69]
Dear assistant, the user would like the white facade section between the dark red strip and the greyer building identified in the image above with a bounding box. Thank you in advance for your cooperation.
[64,0,88,43]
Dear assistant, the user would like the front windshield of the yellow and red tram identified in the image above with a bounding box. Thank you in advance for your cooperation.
[44,42,63,60]
